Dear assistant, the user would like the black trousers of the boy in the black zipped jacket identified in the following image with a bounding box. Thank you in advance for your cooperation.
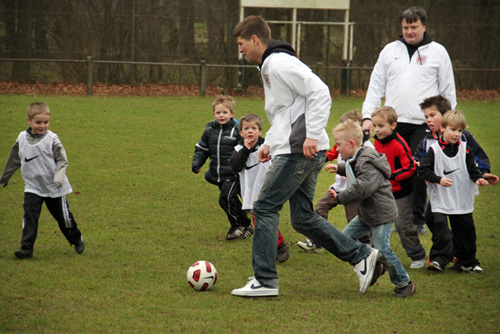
[219,180,252,227]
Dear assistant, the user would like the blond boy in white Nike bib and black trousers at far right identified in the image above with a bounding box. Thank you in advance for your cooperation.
[418,110,488,273]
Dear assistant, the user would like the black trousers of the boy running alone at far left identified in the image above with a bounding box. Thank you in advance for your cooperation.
[21,193,82,252]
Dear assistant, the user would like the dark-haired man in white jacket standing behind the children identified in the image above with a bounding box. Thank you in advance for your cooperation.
[362,7,457,233]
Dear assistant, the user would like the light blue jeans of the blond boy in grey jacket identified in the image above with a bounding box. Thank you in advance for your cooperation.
[342,216,410,288]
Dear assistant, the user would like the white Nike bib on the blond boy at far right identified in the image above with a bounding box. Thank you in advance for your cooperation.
[427,142,479,215]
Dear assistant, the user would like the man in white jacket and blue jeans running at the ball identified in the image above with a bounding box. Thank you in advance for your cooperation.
[232,16,378,297]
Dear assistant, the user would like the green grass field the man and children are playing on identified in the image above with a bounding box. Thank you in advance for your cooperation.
[0,95,500,333]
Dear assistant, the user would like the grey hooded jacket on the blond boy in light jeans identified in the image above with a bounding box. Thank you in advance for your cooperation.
[338,146,398,226]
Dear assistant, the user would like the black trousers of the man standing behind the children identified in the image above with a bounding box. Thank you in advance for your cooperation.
[396,123,427,226]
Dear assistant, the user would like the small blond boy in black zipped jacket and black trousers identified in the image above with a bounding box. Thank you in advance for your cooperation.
[192,95,251,241]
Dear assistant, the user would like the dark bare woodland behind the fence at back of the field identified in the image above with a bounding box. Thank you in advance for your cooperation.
[0,0,500,89]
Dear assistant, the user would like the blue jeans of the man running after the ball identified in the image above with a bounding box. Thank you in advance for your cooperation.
[252,151,371,288]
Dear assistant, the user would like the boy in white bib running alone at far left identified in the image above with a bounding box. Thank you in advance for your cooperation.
[0,102,85,259]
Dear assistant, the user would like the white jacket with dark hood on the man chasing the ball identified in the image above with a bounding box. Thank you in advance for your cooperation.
[260,40,331,156]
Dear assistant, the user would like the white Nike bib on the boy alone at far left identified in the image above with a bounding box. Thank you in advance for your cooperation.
[17,130,73,198]
